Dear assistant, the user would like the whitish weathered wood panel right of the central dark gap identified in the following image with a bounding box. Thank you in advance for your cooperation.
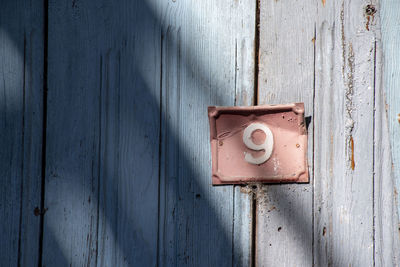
[256,0,400,266]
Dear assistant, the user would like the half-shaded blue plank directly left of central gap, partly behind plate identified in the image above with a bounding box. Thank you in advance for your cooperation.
[157,0,255,266]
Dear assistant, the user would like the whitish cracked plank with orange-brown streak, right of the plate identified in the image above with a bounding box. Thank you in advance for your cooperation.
[314,0,399,266]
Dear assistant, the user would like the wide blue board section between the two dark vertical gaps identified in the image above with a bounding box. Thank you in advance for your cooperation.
[43,1,255,266]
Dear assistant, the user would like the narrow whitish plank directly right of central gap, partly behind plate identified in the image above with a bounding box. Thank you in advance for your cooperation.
[256,0,316,266]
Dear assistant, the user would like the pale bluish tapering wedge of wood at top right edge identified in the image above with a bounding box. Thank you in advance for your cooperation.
[380,0,400,224]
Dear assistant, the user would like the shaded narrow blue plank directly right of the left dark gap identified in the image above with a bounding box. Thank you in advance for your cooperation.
[42,1,104,266]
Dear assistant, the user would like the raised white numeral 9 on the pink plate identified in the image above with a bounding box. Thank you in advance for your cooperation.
[243,123,274,165]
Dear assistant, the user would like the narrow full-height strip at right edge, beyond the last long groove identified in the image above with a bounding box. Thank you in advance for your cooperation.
[374,0,400,266]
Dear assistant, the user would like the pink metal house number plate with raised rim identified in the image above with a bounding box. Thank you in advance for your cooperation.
[208,103,309,185]
